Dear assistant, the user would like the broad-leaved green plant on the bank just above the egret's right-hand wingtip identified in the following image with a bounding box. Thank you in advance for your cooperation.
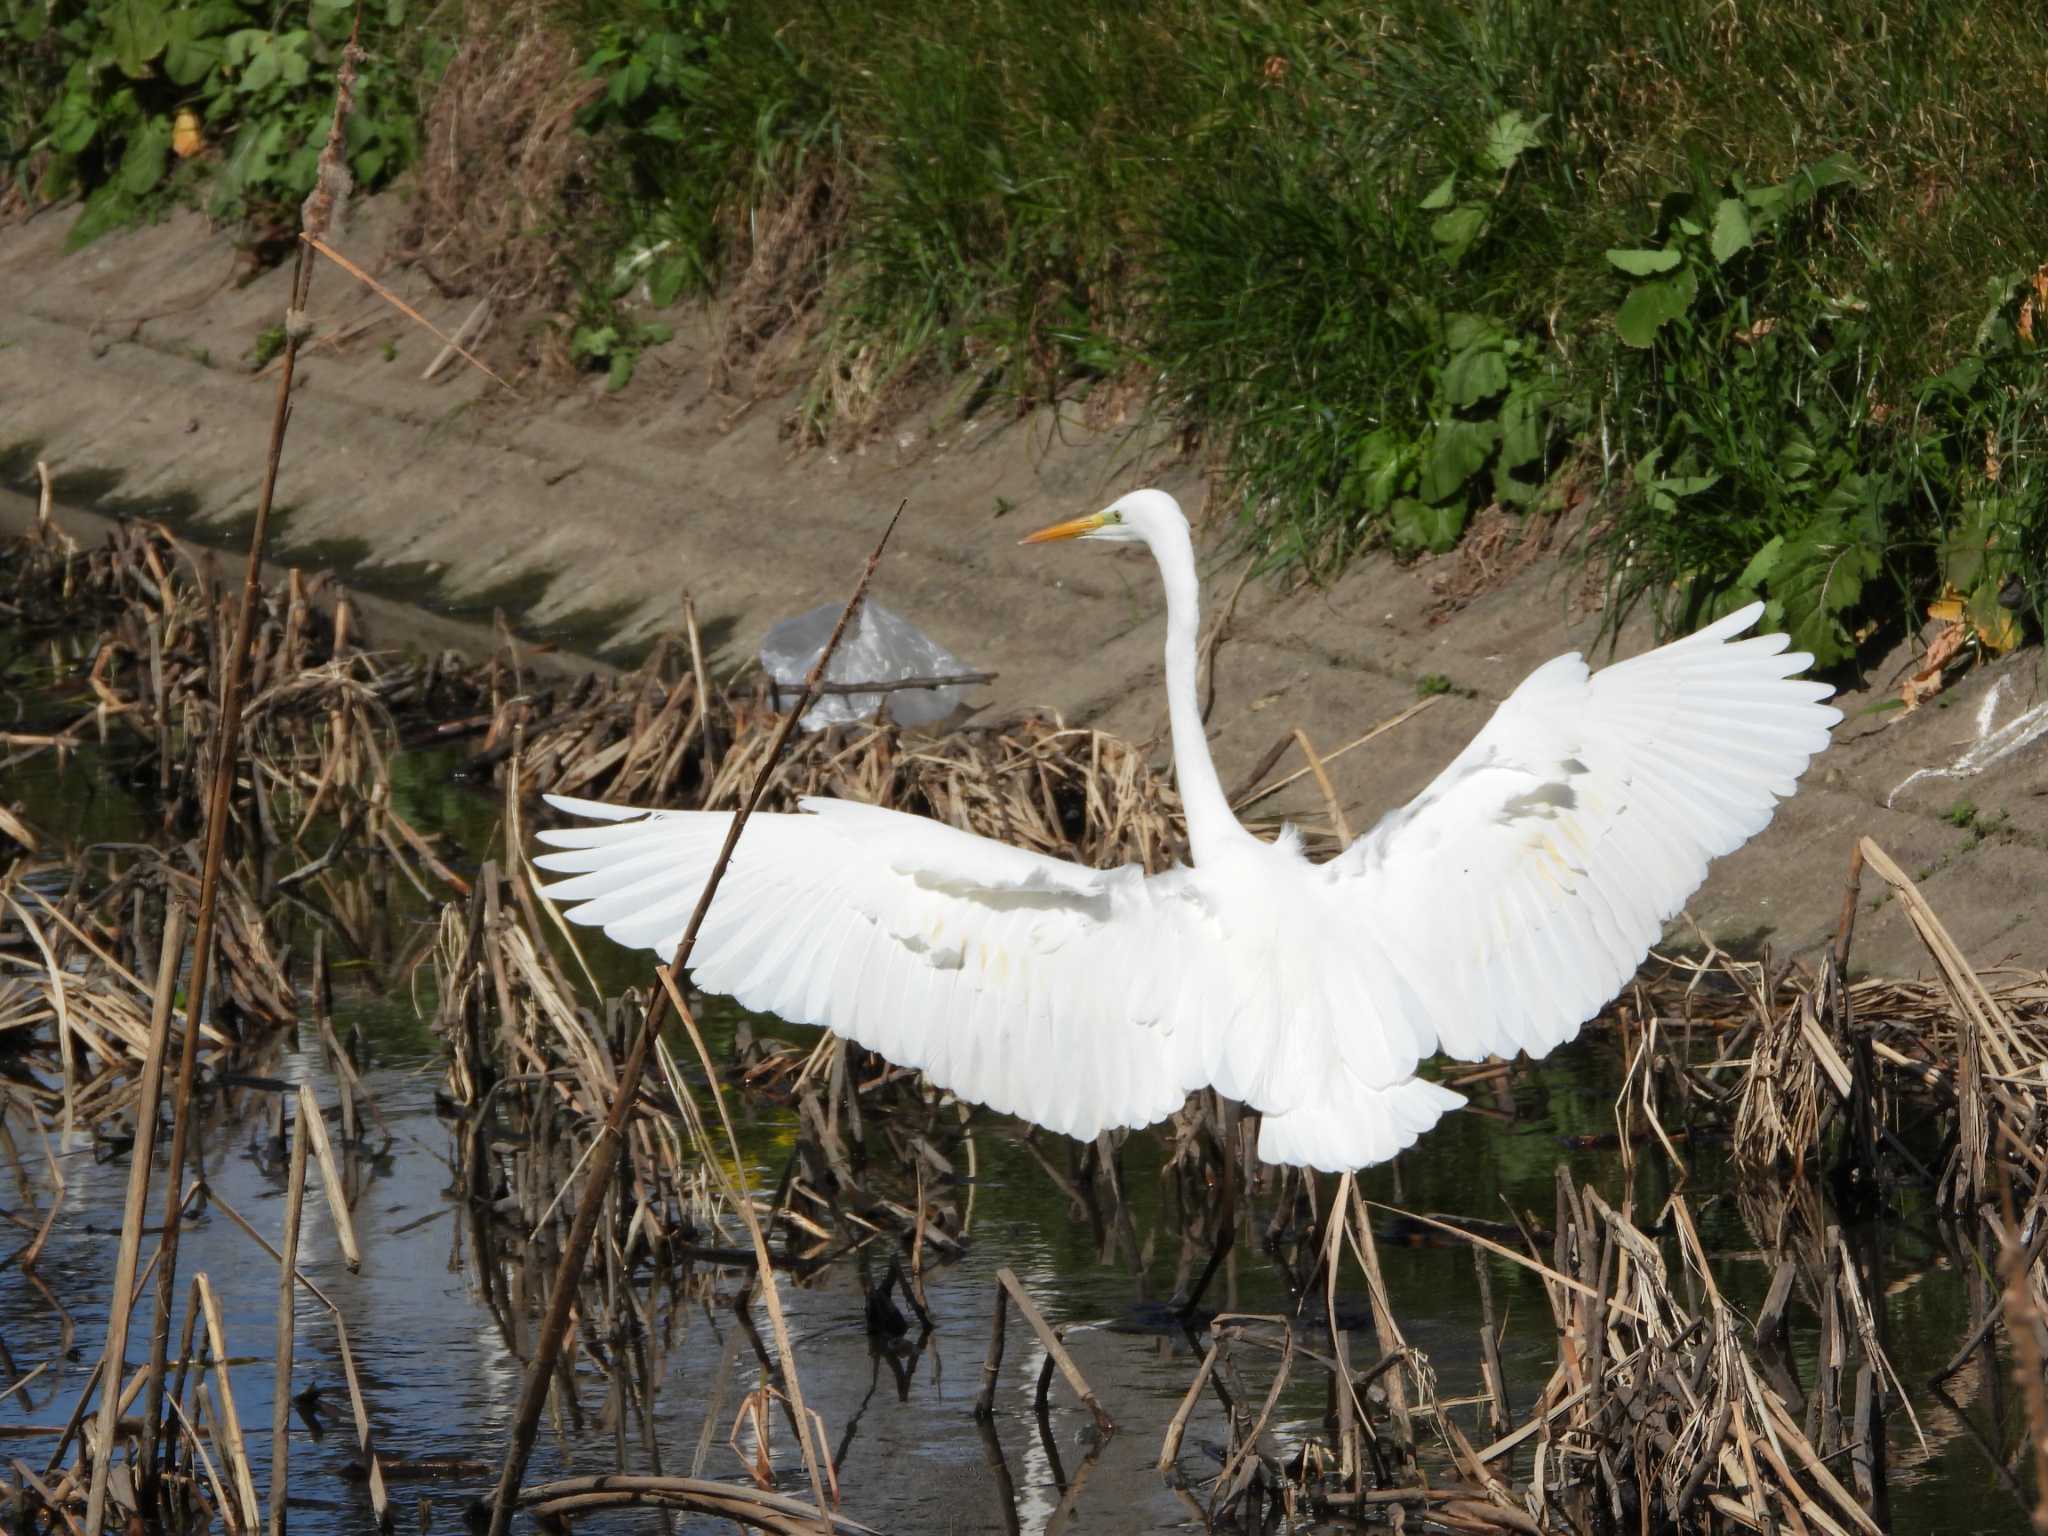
[1604,156,1915,666]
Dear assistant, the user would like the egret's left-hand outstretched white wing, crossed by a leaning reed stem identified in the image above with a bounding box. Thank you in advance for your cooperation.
[535,795,1200,1139]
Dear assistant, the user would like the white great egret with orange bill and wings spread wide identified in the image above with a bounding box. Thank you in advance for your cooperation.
[537,489,1841,1171]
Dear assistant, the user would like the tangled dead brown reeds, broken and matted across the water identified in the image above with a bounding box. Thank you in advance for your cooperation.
[0,507,2048,1532]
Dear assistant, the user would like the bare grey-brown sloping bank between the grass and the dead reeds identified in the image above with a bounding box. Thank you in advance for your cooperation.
[0,201,2048,973]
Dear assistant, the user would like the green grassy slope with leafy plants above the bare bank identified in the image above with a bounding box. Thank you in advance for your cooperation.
[0,0,2048,664]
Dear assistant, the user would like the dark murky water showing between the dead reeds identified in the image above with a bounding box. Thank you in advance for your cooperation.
[0,606,2025,1534]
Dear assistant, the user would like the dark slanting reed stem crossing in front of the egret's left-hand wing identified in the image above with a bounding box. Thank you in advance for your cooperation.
[489,504,907,1536]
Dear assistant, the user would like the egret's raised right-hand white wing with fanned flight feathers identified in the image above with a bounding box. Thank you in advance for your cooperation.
[1321,604,1841,1059]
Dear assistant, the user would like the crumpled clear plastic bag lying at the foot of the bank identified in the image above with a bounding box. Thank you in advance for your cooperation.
[762,602,971,731]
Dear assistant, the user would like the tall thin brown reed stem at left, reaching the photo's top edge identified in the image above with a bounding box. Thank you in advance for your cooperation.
[140,15,362,1507]
